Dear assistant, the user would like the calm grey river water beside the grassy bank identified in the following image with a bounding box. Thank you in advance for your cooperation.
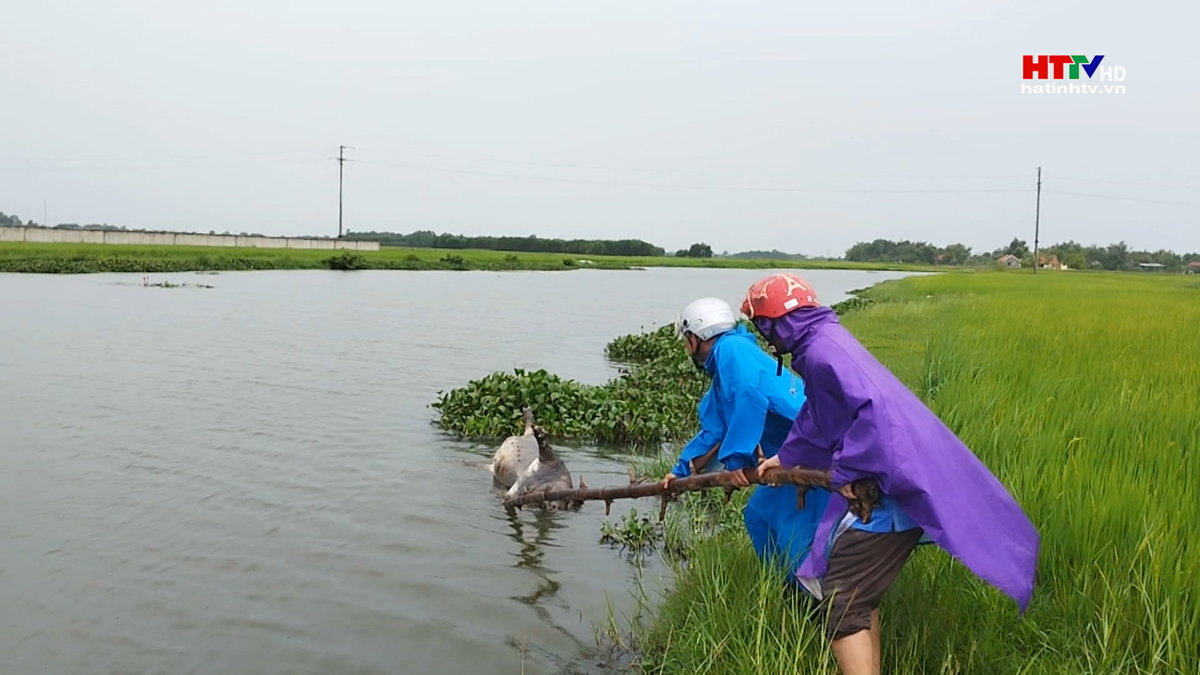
[0,269,904,675]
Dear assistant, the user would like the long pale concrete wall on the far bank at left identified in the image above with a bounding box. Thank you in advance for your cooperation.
[0,227,379,251]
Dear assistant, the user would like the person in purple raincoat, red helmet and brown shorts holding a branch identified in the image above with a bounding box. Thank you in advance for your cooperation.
[742,274,1039,674]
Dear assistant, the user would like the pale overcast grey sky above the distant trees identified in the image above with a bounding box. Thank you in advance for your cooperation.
[0,0,1200,256]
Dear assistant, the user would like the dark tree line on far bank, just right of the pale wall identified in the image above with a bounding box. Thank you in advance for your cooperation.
[346,229,666,256]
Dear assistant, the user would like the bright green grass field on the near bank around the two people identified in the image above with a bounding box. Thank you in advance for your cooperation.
[634,274,1200,674]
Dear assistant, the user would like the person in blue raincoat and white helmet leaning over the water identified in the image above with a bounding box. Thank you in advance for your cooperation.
[662,298,830,586]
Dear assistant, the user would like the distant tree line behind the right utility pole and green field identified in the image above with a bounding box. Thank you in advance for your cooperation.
[846,238,1200,271]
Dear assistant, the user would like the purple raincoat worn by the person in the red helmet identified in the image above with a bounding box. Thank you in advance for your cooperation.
[755,307,1039,614]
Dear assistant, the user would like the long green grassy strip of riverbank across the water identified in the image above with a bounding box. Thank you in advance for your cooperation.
[0,241,940,274]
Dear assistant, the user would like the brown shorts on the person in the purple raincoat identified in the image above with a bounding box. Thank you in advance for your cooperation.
[818,527,922,640]
